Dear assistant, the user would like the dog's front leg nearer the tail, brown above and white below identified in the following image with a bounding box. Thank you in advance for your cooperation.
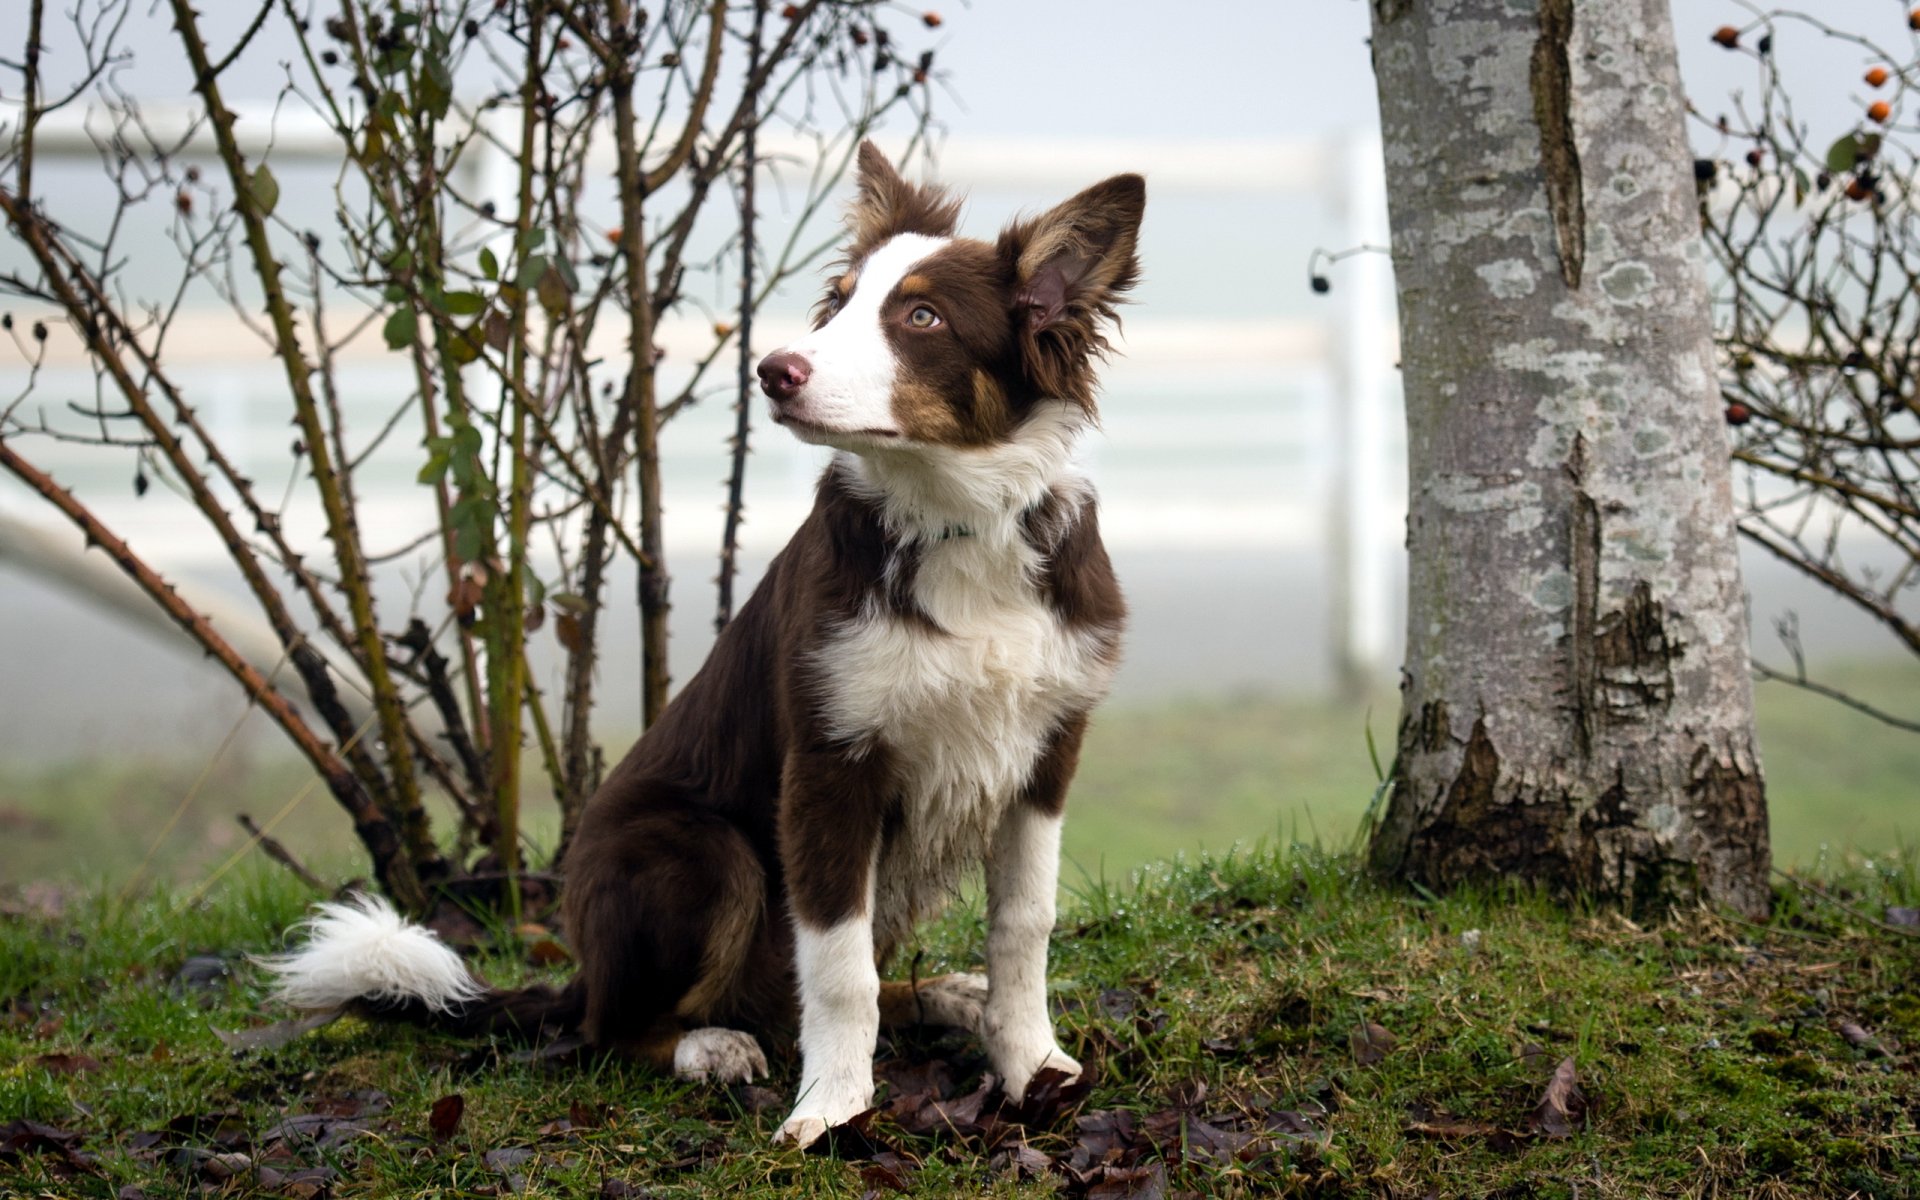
[774,756,879,1146]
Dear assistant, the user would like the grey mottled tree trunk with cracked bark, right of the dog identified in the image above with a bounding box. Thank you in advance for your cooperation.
[1373,0,1768,914]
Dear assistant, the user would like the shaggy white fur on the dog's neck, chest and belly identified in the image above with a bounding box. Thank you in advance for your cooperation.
[818,411,1116,945]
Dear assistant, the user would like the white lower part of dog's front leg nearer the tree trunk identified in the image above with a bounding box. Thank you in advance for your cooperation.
[981,804,1081,1104]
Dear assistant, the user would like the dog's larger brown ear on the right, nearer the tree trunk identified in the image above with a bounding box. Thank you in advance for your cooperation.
[1000,175,1146,411]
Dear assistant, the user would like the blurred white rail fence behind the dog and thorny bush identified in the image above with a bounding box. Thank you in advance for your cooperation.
[0,109,1405,721]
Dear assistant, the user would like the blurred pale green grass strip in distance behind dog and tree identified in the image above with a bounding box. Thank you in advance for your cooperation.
[0,662,1920,883]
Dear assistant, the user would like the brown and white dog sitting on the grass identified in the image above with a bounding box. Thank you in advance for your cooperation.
[273,144,1146,1144]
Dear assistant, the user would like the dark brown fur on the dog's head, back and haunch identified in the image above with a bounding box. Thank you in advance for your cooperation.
[343,146,1144,1066]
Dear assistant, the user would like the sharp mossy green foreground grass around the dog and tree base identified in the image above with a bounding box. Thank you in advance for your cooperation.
[0,849,1920,1200]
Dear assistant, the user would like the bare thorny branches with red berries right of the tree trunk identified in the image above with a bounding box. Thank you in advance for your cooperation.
[1693,8,1920,730]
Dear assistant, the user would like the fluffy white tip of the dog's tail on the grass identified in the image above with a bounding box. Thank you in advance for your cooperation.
[261,893,486,1012]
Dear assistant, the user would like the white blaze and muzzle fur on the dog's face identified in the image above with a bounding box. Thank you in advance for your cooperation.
[764,234,952,444]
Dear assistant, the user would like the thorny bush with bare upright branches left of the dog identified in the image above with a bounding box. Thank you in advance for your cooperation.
[0,0,935,910]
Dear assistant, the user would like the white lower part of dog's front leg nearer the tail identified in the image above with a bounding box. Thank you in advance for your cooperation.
[774,913,879,1146]
